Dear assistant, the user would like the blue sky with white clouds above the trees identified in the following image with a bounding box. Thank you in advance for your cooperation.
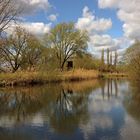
[10,0,140,56]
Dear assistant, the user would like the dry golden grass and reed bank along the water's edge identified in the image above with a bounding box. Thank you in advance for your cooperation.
[0,69,99,86]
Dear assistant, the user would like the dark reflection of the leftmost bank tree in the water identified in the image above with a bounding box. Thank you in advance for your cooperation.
[0,90,41,123]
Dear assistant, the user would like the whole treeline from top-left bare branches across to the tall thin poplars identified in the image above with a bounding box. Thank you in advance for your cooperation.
[0,0,120,72]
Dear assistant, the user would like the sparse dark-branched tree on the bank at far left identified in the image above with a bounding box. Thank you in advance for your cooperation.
[0,27,28,72]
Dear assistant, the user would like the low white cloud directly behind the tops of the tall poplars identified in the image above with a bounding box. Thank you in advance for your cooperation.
[89,34,133,60]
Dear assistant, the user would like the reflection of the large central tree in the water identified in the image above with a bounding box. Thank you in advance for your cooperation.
[50,88,88,133]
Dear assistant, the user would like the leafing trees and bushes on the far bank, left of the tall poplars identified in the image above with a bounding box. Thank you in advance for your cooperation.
[0,23,100,72]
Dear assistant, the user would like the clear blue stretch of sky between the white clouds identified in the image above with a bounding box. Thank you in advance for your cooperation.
[25,0,123,37]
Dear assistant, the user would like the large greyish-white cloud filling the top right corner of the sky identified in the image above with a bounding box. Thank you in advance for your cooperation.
[98,0,140,40]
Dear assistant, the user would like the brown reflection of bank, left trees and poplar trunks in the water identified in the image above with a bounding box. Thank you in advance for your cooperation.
[0,79,118,127]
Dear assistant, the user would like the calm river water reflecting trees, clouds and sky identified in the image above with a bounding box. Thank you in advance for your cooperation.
[0,80,140,140]
